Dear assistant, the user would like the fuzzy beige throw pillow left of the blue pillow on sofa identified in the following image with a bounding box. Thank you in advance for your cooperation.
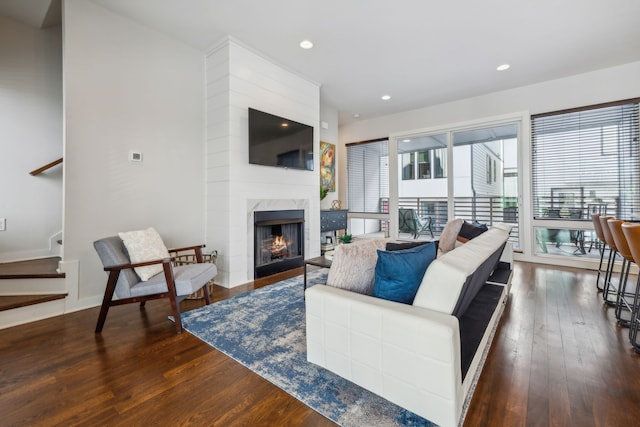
[327,239,389,295]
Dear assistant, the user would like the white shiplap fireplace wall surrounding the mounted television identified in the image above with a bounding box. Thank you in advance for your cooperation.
[206,39,320,286]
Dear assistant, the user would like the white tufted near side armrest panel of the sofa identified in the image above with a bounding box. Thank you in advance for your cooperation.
[305,285,463,425]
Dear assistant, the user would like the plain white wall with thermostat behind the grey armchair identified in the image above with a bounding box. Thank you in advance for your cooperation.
[63,0,205,309]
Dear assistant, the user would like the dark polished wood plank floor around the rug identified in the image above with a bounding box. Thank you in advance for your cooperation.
[0,263,640,426]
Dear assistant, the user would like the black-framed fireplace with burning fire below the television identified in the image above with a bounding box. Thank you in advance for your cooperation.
[253,209,304,279]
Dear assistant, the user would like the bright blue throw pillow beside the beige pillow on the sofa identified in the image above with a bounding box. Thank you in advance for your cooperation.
[373,242,436,304]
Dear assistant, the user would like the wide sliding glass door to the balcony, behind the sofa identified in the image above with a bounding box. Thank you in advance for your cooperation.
[396,121,519,248]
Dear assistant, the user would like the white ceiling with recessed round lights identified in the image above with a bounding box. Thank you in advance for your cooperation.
[0,0,640,123]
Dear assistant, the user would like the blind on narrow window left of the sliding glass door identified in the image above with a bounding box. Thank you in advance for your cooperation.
[347,139,389,213]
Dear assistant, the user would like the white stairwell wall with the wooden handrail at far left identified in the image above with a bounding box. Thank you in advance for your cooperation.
[0,16,62,262]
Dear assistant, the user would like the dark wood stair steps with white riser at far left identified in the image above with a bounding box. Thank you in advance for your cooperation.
[0,257,67,314]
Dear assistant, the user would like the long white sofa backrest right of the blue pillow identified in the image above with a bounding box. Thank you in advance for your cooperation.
[413,227,509,314]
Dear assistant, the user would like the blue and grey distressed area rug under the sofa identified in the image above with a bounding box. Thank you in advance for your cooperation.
[182,270,435,426]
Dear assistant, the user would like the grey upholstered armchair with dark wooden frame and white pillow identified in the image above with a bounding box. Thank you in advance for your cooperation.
[93,229,218,333]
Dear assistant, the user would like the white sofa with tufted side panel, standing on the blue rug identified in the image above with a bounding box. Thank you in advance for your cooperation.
[305,224,511,426]
